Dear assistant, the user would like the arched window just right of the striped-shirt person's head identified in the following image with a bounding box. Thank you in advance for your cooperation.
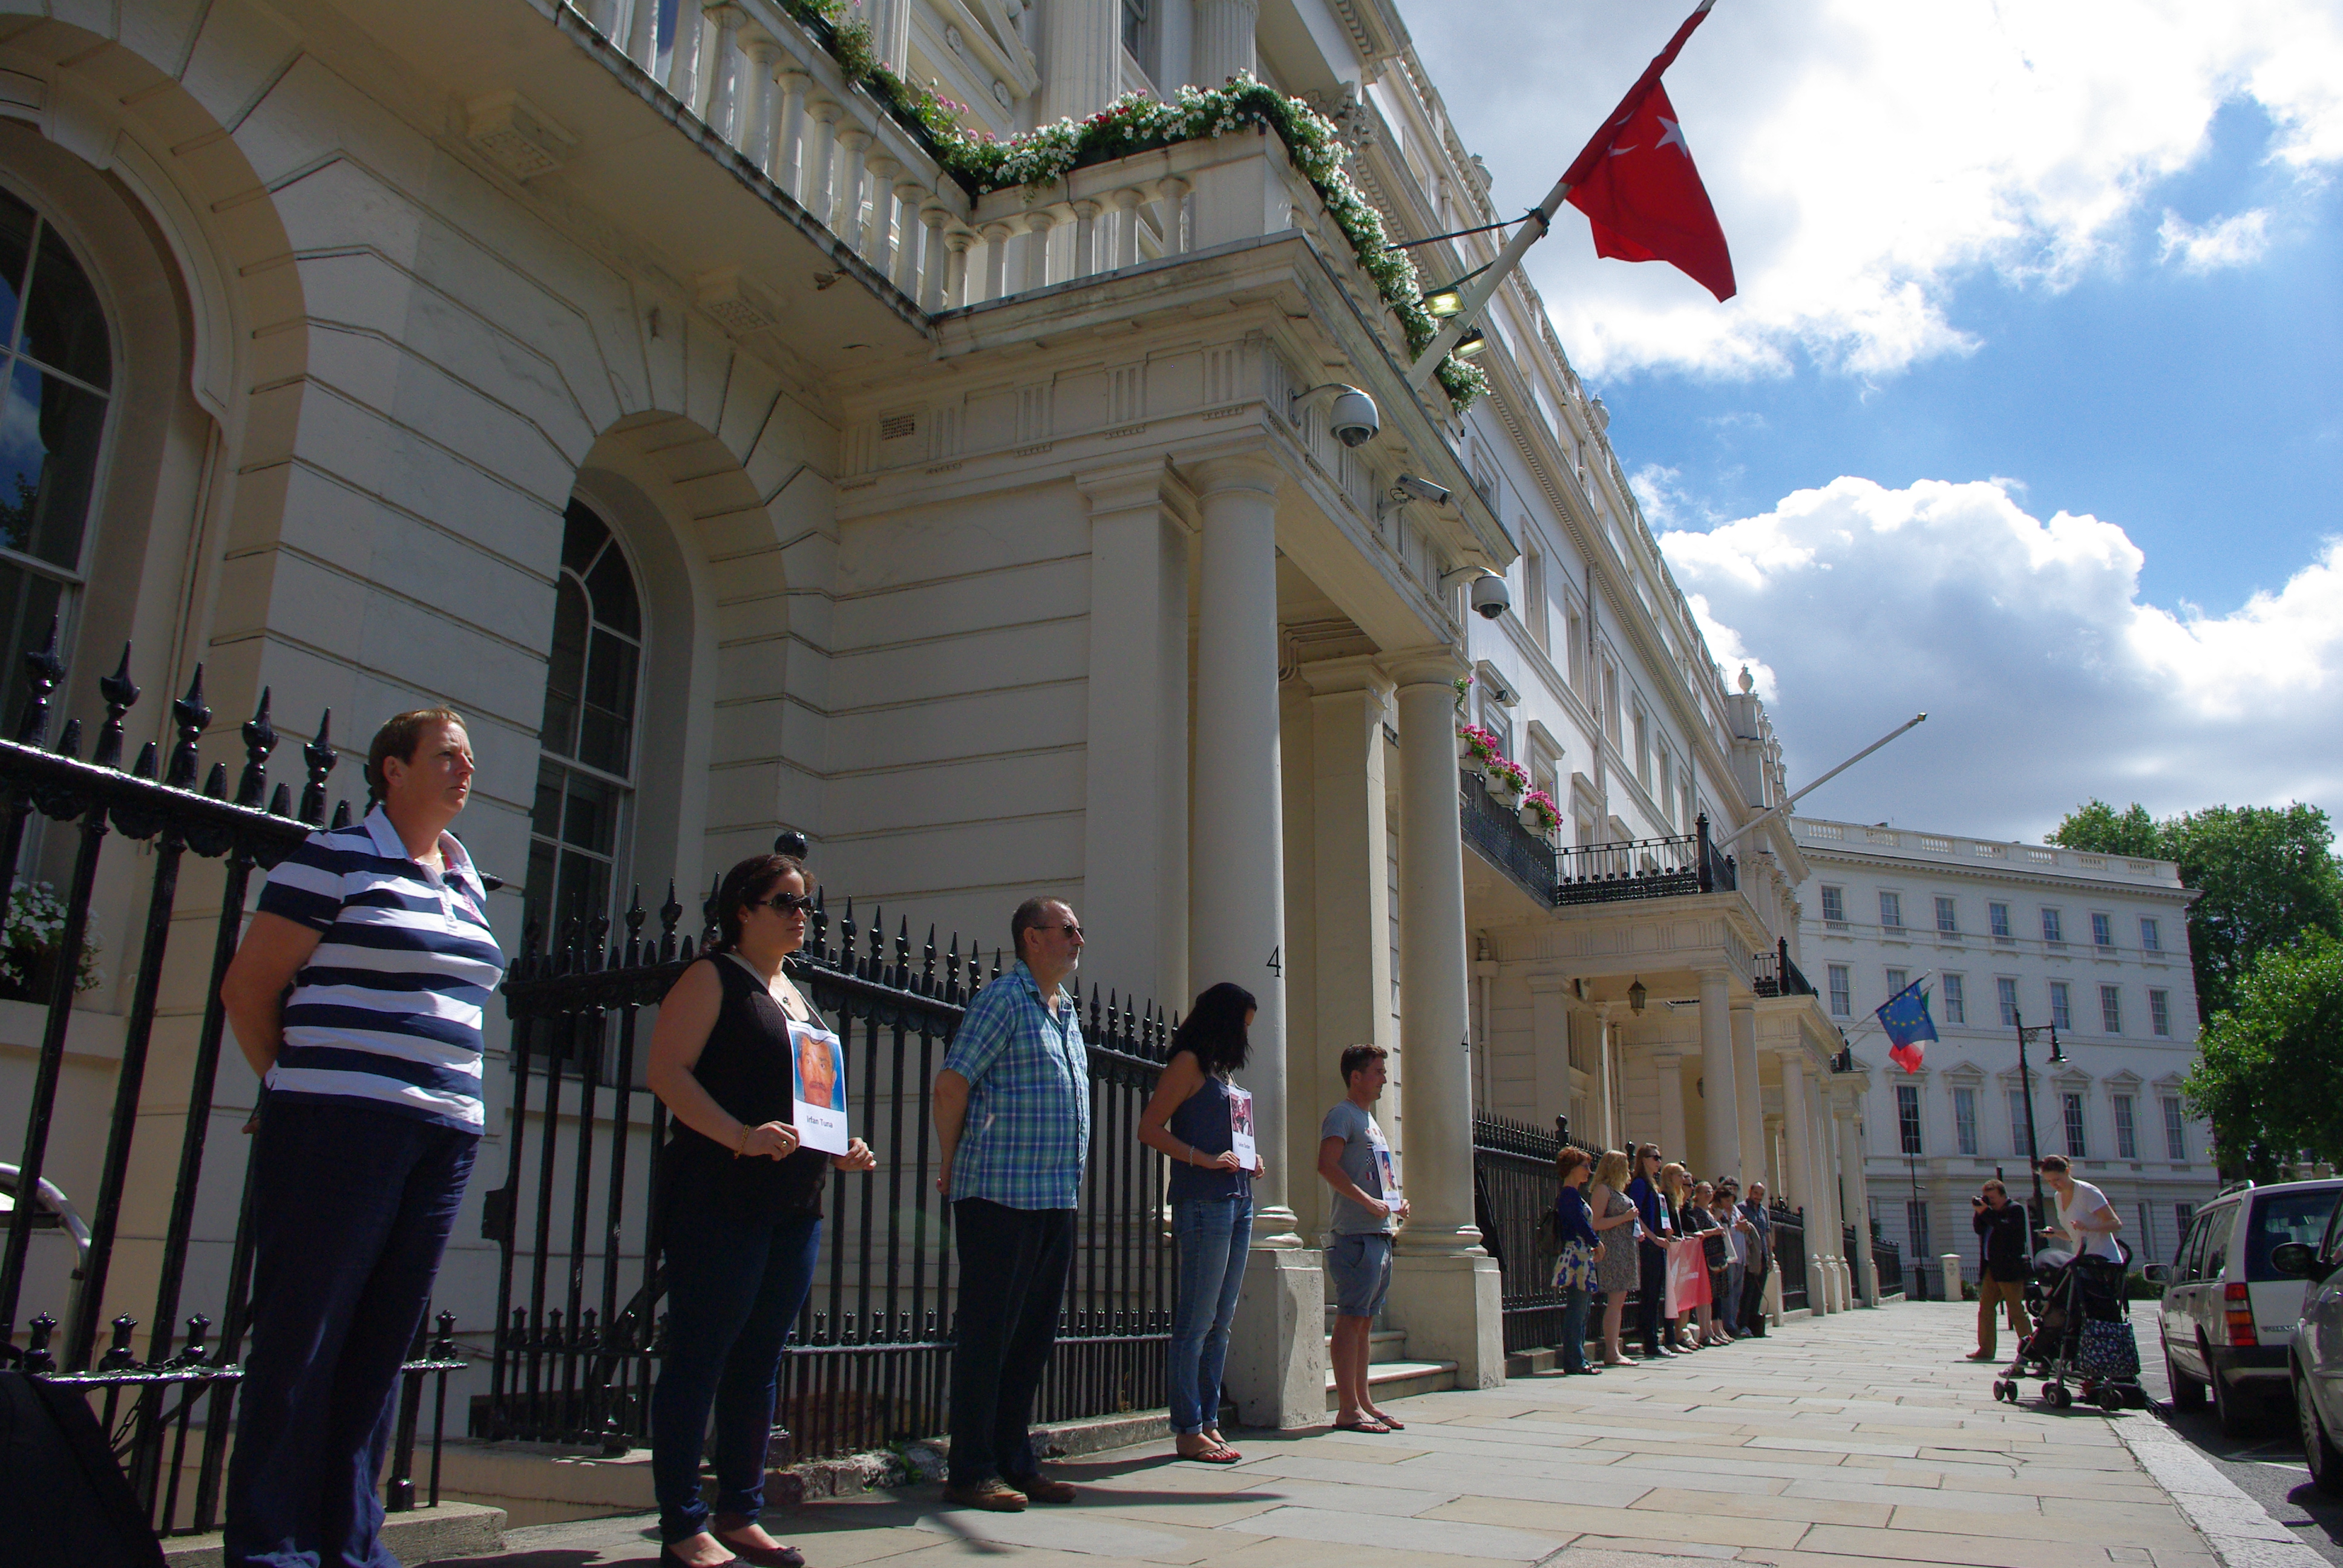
[525,501,642,942]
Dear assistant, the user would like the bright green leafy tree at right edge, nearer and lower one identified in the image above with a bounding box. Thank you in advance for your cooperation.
[2181,930,2343,1181]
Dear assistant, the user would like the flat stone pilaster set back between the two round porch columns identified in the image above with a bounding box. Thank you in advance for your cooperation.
[1286,659,1406,1235]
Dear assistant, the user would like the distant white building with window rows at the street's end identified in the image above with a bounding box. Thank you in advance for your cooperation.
[1797,818,2219,1278]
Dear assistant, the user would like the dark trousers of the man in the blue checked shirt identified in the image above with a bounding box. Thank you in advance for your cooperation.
[946,1198,1073,1486]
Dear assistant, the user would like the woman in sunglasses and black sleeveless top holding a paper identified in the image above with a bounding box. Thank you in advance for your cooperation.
[649,855,876,1568]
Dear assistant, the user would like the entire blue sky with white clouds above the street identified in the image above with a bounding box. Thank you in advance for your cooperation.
[1401,0,2343,837]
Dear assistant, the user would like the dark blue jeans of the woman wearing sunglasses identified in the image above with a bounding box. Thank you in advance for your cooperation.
[651,1191,822,1544]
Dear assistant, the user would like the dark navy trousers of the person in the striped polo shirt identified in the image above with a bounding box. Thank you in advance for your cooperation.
[223,1099,480,1568]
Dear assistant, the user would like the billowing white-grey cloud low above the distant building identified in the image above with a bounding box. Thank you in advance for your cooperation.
[1661,478,2343,837]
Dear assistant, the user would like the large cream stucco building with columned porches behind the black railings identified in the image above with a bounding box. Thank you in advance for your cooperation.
[0,0,1884,1481]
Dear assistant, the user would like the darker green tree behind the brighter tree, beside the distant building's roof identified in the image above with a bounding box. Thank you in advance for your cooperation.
[2050,799,2343,1019]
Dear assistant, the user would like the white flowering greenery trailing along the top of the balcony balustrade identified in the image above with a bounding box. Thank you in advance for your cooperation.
[782,0,1488,410]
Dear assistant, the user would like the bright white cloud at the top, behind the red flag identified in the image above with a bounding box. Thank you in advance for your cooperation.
[1401,0,2343,375]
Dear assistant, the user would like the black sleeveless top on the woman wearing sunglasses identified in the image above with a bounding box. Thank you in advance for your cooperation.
[661,954,830,1219]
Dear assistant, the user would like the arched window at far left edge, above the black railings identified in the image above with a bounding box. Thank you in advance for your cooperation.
[0,190,115,734]
